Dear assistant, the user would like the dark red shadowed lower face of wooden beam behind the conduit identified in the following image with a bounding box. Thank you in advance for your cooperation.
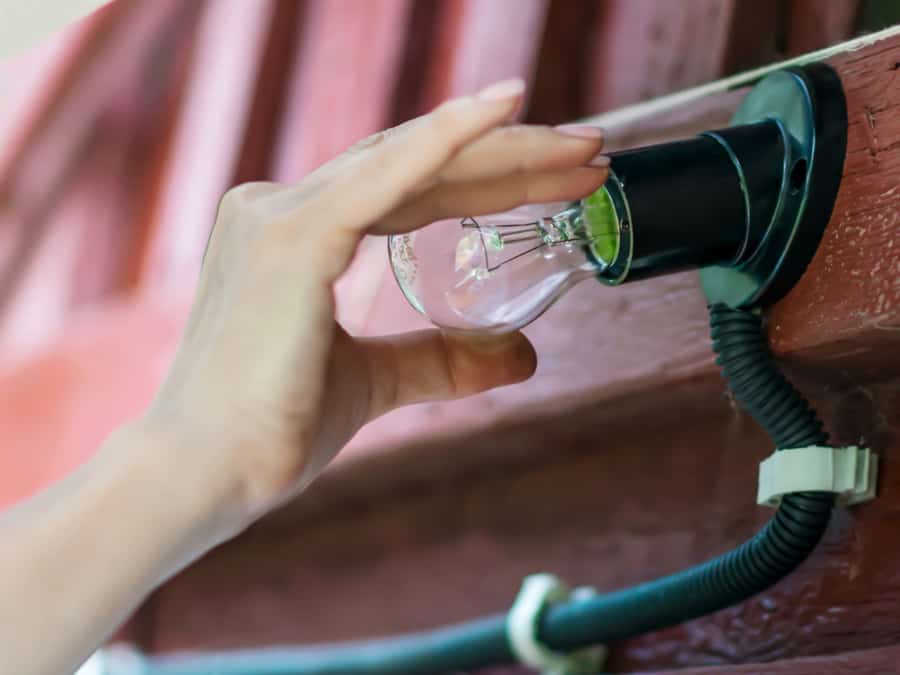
[139,376,900,672]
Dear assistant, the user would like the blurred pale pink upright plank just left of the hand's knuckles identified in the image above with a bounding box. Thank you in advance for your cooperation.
[140,0,274,293]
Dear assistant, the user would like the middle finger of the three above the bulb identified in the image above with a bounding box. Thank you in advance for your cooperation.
[437,124,608,181]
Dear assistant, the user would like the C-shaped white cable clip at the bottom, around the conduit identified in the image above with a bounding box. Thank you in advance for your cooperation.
[506,574,606,675]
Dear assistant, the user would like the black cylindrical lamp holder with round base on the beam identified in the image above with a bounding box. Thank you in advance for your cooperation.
[599,64,847,309]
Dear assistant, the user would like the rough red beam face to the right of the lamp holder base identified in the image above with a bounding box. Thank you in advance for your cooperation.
[769,39,900,378]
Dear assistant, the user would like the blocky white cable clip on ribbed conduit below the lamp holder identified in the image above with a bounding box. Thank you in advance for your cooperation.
[756,445,878,506]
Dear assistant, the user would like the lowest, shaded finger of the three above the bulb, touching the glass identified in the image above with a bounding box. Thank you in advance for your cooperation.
[372,167,609,234]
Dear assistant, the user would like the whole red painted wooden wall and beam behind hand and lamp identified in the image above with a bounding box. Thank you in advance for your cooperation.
[0,0,900,673]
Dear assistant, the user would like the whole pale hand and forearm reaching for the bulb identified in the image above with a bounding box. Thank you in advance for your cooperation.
[0,80,607,675]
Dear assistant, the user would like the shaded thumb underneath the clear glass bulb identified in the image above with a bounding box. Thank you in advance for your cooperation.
[357,330,537,420]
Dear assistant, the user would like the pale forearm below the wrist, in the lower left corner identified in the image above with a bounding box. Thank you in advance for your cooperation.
[0,426,229,675]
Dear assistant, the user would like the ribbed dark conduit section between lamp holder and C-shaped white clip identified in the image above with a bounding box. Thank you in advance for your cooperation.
[540,305,834,650]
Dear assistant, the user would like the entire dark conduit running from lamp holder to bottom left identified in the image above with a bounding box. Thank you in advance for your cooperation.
[142,305,834,675]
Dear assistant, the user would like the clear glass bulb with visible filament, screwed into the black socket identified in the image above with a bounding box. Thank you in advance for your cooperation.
[388,188,620,334]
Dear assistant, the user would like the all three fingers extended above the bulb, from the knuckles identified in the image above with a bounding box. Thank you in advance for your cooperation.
[232,79,607,283]
